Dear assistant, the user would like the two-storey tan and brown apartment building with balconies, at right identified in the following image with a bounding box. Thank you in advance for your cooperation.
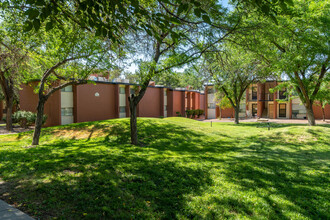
[205,81,330,119]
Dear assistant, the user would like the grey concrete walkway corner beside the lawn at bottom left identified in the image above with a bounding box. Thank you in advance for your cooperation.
[0,200,33,220]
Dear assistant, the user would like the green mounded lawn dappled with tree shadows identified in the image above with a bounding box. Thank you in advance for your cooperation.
[0,118,330,219]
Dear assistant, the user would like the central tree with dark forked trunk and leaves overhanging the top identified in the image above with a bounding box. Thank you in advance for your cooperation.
[0,0,296,144]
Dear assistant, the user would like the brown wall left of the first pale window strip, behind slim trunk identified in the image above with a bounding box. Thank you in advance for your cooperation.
[19,84,61,127]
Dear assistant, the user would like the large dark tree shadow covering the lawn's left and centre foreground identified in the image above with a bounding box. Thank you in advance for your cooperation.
[1,142,211,219]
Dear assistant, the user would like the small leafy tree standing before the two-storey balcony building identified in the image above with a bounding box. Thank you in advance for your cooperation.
[208,44,268,124]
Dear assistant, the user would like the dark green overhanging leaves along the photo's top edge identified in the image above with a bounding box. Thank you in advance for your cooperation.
[0,0,292,42]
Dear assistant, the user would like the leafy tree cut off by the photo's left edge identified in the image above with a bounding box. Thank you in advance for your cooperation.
[0,13,33,131]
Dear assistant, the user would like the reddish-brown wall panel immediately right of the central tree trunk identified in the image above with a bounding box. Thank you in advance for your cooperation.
[139,87,163,117]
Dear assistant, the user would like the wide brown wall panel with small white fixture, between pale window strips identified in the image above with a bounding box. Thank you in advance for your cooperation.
[75,83,119,122]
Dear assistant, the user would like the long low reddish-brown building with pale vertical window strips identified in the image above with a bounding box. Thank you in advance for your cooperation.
[0,78,205,126]
